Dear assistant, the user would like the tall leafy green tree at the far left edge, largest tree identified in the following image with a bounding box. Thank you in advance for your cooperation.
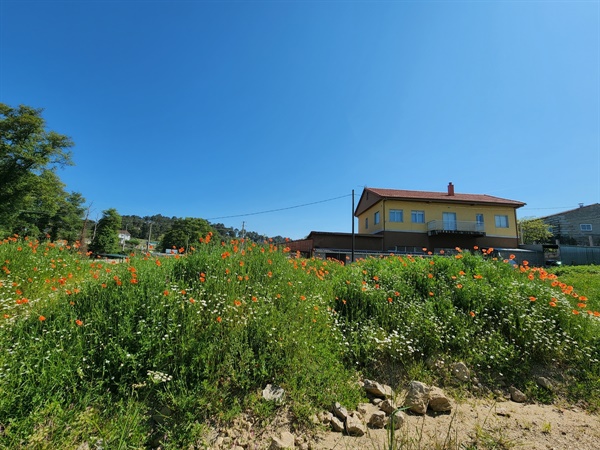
[0,103,73,232]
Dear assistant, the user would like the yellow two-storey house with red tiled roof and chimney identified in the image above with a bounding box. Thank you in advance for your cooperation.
[354,183,525,252]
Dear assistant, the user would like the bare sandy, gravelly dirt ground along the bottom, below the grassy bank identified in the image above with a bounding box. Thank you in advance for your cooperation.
[216,399,600,450]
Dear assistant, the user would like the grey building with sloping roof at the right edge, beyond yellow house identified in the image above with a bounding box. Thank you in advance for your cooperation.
[540,203,600,246]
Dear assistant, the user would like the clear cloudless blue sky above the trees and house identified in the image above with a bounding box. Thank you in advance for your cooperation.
[0,0,600,239]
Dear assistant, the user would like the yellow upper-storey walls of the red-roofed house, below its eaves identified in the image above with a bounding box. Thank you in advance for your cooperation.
[358,199,517,238]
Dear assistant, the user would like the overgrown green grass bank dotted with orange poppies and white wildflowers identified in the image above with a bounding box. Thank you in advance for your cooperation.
[0,238,600,448]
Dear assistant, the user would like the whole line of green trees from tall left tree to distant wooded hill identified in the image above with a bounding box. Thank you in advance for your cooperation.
[0,103,284,253]
